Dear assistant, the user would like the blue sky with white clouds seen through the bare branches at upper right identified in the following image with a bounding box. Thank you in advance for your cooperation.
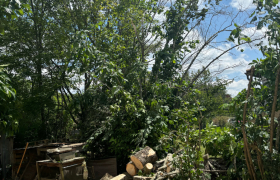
[150,0,267,96]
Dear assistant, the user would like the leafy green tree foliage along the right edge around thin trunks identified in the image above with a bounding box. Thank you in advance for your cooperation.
[222,0,280,179]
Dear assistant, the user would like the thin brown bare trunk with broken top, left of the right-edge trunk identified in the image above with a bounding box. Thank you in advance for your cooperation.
[242,66,256,180]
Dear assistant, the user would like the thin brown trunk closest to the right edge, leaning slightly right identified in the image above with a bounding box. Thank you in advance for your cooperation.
[269,66,280,153]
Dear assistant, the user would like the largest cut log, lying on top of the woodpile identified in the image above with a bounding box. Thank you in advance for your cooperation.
[130,146,158,170]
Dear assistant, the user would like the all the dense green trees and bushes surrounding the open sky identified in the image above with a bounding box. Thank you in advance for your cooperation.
[0,0,280,179]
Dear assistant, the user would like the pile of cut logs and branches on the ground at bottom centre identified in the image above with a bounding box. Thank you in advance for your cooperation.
[107,146,179,180]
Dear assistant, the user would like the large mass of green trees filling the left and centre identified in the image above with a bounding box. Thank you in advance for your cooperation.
[0,0,247,178]
